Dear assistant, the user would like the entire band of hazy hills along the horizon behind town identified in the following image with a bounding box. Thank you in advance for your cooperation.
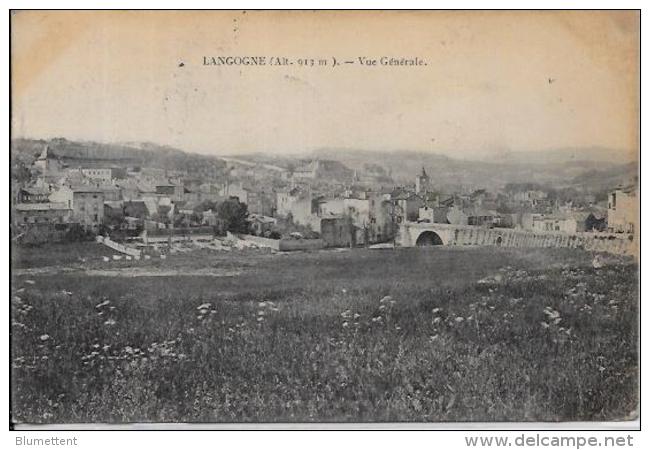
[11,138,637,192]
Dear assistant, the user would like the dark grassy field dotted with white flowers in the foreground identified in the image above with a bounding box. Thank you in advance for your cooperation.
[11,243,638,423]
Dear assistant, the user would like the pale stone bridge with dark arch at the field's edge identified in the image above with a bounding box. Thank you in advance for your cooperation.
[396,222,636,254]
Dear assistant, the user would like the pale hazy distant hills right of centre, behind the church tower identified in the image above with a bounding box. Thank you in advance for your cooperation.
[220,147,636,191]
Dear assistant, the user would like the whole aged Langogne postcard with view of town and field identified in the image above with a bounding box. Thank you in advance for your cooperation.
[7,10,641,428]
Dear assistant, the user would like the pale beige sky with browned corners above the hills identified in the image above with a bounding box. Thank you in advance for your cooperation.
[11,11,639,162]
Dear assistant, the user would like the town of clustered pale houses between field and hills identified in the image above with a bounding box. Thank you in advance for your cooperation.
[11,139,638,256]
